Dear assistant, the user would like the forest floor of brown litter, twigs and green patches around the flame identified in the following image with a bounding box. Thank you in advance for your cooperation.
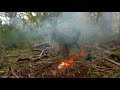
[0,41,120,78]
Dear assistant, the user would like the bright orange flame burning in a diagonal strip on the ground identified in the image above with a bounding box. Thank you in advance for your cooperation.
[58,52,85,69]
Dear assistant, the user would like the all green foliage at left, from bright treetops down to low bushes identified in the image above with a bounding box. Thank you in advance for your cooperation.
[0,12,62,49]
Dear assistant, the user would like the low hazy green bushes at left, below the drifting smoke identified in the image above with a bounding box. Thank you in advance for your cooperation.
[0,25,44,49]
